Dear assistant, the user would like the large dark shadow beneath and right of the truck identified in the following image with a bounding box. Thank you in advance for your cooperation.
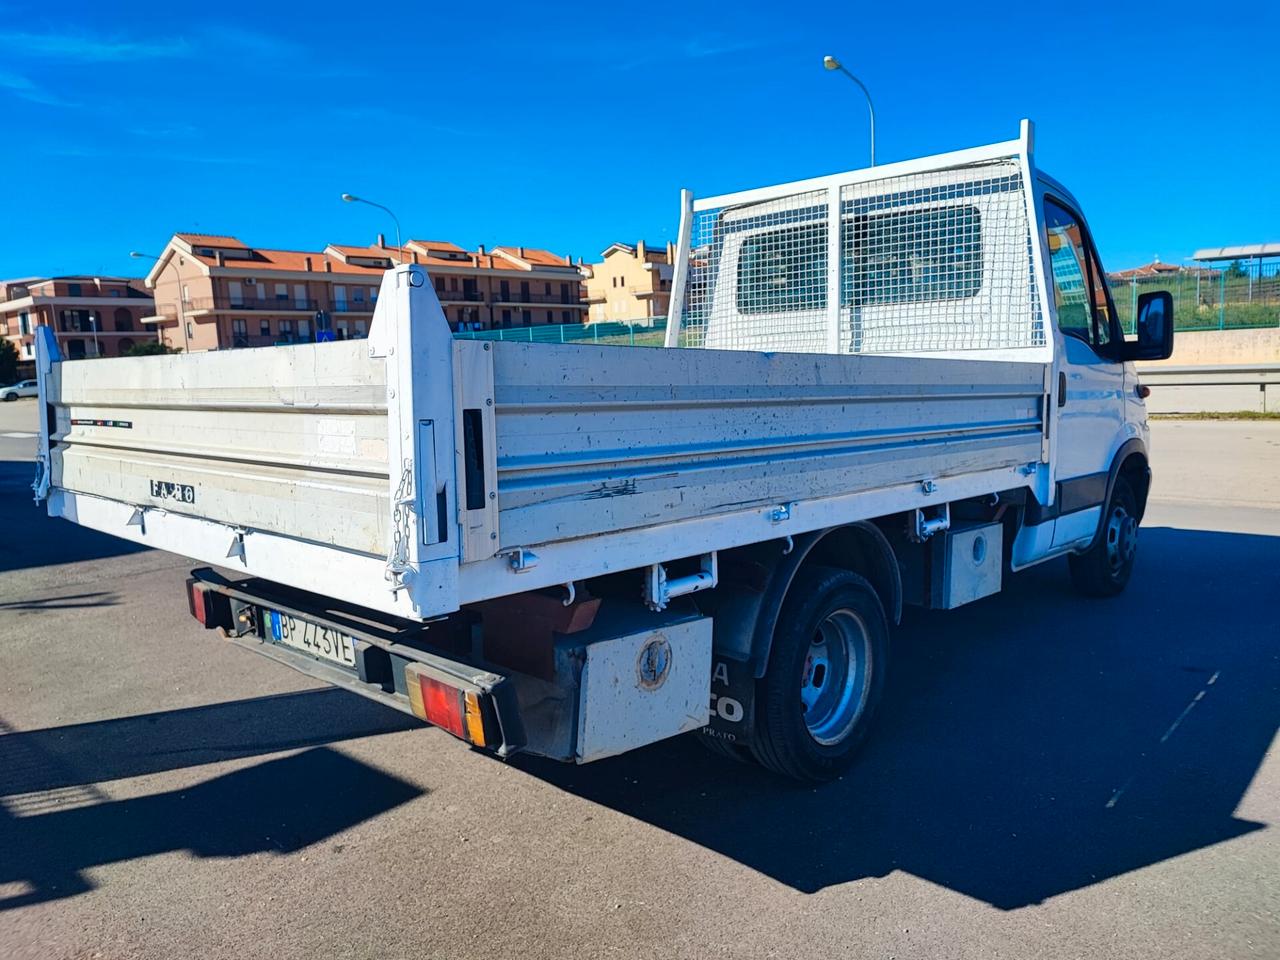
[518,527,1280,910]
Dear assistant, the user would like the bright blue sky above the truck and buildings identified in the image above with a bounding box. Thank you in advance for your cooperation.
[0,0,1280,276]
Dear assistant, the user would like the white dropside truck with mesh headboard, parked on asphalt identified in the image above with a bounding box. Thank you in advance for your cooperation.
[35,122,1172,781]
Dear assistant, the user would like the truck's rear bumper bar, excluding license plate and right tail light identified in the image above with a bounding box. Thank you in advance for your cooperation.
[188,567,526,756]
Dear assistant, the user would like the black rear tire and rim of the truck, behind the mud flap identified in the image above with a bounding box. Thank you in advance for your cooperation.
[750,567,888,782]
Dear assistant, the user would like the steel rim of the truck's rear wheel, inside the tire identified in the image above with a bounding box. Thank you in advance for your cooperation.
[800,608,872,746]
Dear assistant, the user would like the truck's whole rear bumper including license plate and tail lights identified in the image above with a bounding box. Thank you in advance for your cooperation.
[187,567,526,756]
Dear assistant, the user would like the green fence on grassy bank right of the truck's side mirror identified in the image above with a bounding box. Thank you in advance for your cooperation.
[1111,261,1280,333]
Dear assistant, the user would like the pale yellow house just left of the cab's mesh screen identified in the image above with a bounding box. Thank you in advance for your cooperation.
[582,241,676,324]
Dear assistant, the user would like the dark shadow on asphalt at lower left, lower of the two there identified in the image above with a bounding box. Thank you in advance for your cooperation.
[0,748,426,910]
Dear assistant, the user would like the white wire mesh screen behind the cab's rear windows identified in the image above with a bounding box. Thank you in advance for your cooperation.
[680,160,1044,353]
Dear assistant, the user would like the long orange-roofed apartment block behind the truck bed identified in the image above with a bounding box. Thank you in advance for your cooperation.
[146,233,585,351]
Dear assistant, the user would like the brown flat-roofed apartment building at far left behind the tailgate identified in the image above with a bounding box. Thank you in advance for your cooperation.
[0,274,155,370]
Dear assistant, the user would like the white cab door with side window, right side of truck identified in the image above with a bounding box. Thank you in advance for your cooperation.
[1044,196,1125,549]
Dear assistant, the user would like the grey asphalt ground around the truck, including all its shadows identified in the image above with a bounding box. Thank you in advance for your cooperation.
[0,403,1280,960]
